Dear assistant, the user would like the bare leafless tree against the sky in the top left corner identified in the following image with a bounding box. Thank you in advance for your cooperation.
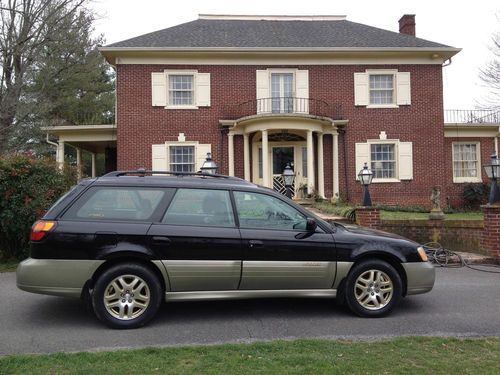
[0,0,88,154]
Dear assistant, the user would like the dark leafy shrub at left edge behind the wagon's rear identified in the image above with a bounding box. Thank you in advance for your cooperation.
[0,155,76,260]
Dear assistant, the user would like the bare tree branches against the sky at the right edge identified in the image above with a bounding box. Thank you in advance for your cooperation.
[479,17,500,112]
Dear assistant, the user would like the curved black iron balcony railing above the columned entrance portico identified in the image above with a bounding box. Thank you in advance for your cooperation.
[223,97,342,120]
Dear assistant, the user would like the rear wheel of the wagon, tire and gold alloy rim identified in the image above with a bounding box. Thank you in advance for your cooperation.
[92,263,162,329]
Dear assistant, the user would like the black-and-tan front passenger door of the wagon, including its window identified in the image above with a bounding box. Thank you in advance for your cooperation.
[233,191,336,290]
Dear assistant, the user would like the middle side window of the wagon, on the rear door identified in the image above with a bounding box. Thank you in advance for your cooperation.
[162,189,235,227]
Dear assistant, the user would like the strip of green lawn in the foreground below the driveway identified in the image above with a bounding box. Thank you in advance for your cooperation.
[0,340,500,375]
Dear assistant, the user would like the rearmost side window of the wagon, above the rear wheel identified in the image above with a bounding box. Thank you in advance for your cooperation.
[63,187,165,221]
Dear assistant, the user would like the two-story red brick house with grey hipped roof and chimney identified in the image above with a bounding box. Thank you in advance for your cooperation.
[48,15,498,206]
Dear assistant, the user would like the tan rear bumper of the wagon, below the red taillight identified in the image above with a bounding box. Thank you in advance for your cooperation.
[16,258,104,297]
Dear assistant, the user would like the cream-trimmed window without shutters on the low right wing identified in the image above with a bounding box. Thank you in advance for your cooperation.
[453,142,481,182]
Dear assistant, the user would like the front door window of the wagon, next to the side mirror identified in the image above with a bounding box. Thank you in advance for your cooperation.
[234,191,307,231]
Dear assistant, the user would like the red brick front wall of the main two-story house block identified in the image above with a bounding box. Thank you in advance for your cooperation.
[117,65,446,206]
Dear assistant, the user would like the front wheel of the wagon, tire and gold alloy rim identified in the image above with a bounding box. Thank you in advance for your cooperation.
[345,259,403,318]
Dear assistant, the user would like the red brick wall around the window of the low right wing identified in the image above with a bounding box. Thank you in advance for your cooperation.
[441,137,495,207]
